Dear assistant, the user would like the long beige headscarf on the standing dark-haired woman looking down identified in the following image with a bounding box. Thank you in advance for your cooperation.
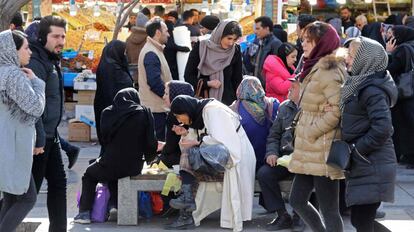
[197,21,236,101]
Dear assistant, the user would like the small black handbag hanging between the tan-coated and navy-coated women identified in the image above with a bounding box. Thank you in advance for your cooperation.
[326,123,352,170]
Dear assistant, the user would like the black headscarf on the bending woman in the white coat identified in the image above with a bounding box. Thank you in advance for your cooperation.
[171,95,214,130]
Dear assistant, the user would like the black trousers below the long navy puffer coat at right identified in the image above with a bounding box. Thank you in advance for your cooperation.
[351,202,390,232]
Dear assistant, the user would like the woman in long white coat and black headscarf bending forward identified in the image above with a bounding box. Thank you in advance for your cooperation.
[170,96,256,231]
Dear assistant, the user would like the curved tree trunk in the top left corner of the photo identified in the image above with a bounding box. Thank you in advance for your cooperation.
[0,0,30,31]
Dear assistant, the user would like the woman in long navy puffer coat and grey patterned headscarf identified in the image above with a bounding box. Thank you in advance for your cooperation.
[340,37,398,232]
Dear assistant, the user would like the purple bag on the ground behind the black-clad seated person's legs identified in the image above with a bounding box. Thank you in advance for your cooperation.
[77,183,110,222]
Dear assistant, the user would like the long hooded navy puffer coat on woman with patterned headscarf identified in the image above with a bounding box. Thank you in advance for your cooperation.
[342,72,398,206]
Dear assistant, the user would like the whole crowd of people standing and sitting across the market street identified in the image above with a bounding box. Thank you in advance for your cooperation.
[0,6,414,232]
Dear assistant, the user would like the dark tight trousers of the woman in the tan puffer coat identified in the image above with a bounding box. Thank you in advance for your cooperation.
[289,174,343,232]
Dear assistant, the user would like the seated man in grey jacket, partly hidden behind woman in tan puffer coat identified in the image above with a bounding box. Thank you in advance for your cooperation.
[256,78,304,231]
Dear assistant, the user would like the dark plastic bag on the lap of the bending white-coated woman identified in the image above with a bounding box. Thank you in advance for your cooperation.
[188,144,230,175]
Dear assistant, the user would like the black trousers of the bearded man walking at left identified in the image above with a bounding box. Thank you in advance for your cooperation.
[32,139,67,232]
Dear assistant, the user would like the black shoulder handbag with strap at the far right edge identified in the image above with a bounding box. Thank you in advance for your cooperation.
[397,45,414,99]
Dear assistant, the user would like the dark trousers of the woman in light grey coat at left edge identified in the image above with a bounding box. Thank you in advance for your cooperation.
[0,177,37,232]
